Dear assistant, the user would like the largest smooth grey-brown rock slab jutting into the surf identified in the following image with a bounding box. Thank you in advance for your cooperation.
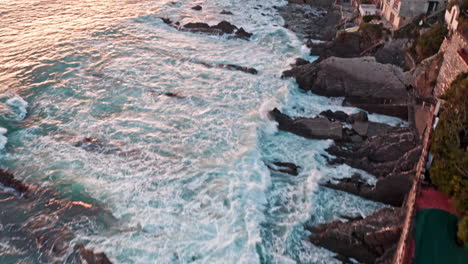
[283,57,412,119]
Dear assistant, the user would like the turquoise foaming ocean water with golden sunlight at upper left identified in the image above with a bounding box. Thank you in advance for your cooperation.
[0,0,388,264]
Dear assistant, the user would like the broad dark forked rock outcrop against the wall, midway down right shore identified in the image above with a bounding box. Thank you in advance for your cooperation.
[324,125,421,206]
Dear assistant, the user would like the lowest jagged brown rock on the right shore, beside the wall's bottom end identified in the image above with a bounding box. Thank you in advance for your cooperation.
[306,208,404,263]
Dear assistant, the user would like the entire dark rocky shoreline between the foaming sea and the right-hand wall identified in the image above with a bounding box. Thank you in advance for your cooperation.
[269,1,440,263]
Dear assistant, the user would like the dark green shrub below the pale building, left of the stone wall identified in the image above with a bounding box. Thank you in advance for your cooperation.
[415,23,448,61]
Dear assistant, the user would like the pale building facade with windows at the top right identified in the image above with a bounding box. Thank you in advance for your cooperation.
[380,0,447,29]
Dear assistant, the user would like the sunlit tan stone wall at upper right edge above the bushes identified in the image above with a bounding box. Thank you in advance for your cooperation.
[434,30,468,96]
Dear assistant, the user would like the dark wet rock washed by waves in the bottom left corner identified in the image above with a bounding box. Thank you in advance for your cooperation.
[0,170,117,264]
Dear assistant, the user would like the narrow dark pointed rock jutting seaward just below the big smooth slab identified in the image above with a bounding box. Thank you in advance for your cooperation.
[269,108,343,140]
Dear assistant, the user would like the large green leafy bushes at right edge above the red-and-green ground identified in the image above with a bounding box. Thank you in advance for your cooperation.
[430,73,468,243]
